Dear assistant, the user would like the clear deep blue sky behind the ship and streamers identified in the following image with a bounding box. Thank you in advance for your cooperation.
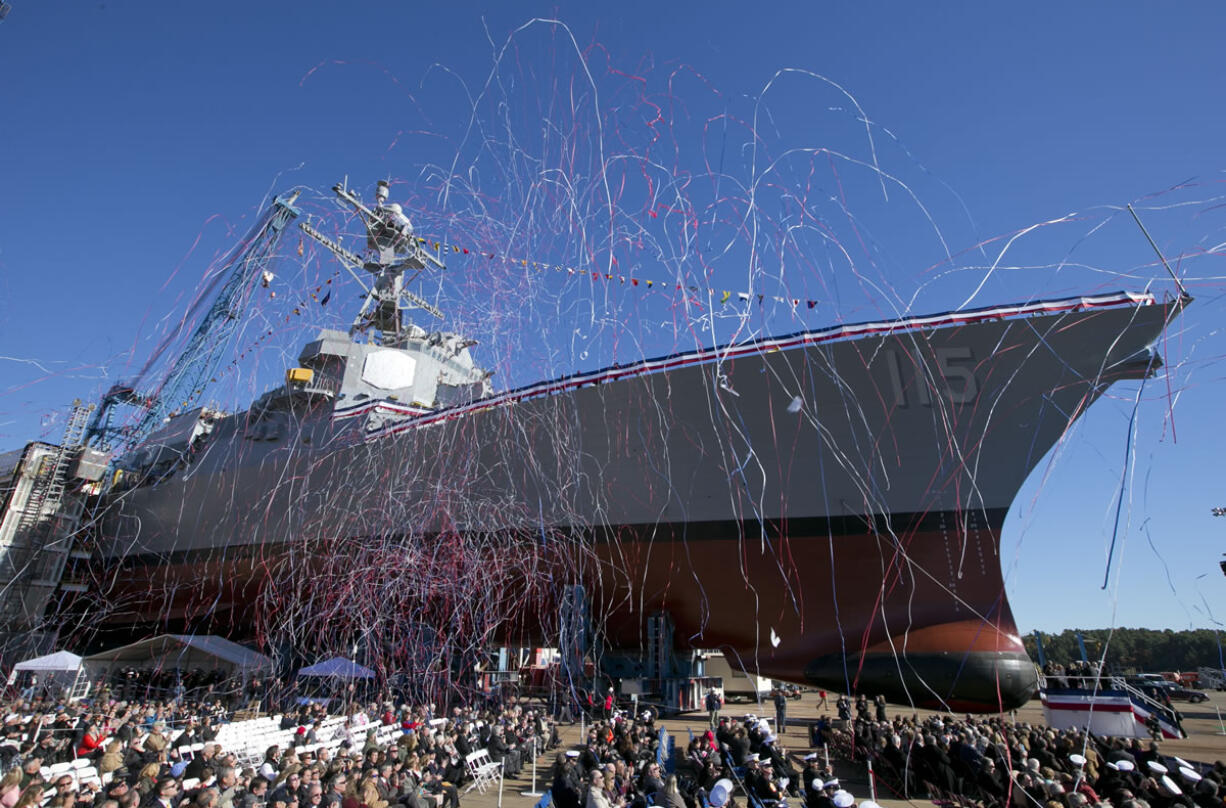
[0,0,1226,630]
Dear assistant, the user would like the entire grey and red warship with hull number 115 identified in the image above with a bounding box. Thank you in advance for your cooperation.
[0,184,1186,711]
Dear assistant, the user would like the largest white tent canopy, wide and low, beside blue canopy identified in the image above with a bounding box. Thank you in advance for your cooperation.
[83,634,272,676]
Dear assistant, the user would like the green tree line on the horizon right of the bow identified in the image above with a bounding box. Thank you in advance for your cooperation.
[1022,629,1226,673]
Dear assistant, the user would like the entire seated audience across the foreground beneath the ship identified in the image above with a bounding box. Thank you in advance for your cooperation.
[0,671,1226,808]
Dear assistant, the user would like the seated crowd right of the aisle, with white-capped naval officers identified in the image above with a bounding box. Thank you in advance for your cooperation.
[552,696,1226,808]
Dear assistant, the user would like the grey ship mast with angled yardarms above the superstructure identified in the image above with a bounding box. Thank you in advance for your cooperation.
[298,180,446,346]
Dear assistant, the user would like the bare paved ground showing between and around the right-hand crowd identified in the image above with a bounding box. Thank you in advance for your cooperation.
[461,693,1226,808]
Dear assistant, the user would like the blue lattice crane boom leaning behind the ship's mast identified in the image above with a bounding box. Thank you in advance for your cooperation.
[85,191,299,456]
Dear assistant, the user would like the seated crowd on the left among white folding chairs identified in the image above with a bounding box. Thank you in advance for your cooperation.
[0,699,560,808]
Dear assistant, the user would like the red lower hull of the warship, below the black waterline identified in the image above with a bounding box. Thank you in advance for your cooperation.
[76,513,1037,712]
